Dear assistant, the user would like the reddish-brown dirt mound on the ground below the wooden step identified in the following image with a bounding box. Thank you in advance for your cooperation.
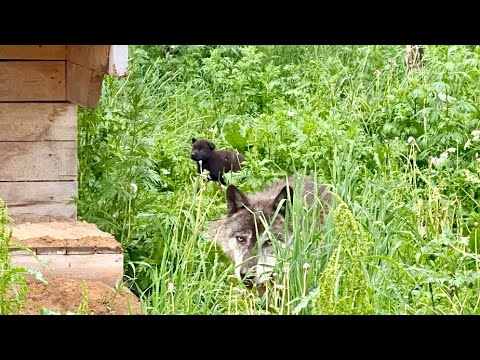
[20,278,142,315]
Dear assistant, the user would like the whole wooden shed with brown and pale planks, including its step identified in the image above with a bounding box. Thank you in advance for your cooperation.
[0,45,128,283]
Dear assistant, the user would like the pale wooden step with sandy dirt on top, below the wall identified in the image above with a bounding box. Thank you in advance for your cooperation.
[10,220,123,286]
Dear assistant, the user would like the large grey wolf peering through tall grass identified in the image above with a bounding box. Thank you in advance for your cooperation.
[208,177,332,295]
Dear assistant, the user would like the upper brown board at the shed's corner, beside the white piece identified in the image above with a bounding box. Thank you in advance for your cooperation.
[67,45,110,74]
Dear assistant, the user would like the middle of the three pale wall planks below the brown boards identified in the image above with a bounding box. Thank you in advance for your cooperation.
[0,141,77,181]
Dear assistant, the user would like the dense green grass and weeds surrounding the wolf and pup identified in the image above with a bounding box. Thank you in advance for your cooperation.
[71,46,480,314]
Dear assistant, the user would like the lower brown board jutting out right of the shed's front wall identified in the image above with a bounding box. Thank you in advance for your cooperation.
[67,61,103,108]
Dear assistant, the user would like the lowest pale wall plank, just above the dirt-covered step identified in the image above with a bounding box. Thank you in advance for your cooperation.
[0,181,77,220]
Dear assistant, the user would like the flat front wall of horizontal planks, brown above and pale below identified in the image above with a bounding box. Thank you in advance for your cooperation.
[0,45,77,218]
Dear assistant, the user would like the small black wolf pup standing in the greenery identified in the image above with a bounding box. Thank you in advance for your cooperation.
[191,138,245,185]
